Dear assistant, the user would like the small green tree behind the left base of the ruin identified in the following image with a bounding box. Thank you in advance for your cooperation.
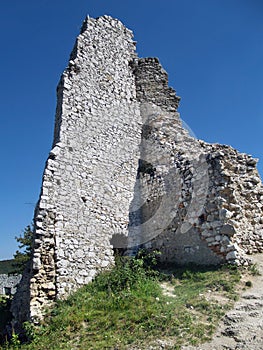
[13,224,33,273]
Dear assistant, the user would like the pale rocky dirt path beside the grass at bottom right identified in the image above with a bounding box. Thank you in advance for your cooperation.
[182,254,263,350]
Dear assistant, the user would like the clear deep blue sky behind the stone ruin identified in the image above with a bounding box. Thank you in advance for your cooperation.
[0,0,263,260]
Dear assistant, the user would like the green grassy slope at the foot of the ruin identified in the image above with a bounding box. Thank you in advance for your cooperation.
[2,252,244,350]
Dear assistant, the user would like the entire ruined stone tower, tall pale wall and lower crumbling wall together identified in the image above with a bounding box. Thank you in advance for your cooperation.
[13,16,263,320]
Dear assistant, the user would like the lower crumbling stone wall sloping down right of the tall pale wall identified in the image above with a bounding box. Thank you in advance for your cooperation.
[127,59,263,265]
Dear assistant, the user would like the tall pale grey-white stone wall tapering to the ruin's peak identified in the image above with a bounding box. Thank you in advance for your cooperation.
[30,17,141,316]
